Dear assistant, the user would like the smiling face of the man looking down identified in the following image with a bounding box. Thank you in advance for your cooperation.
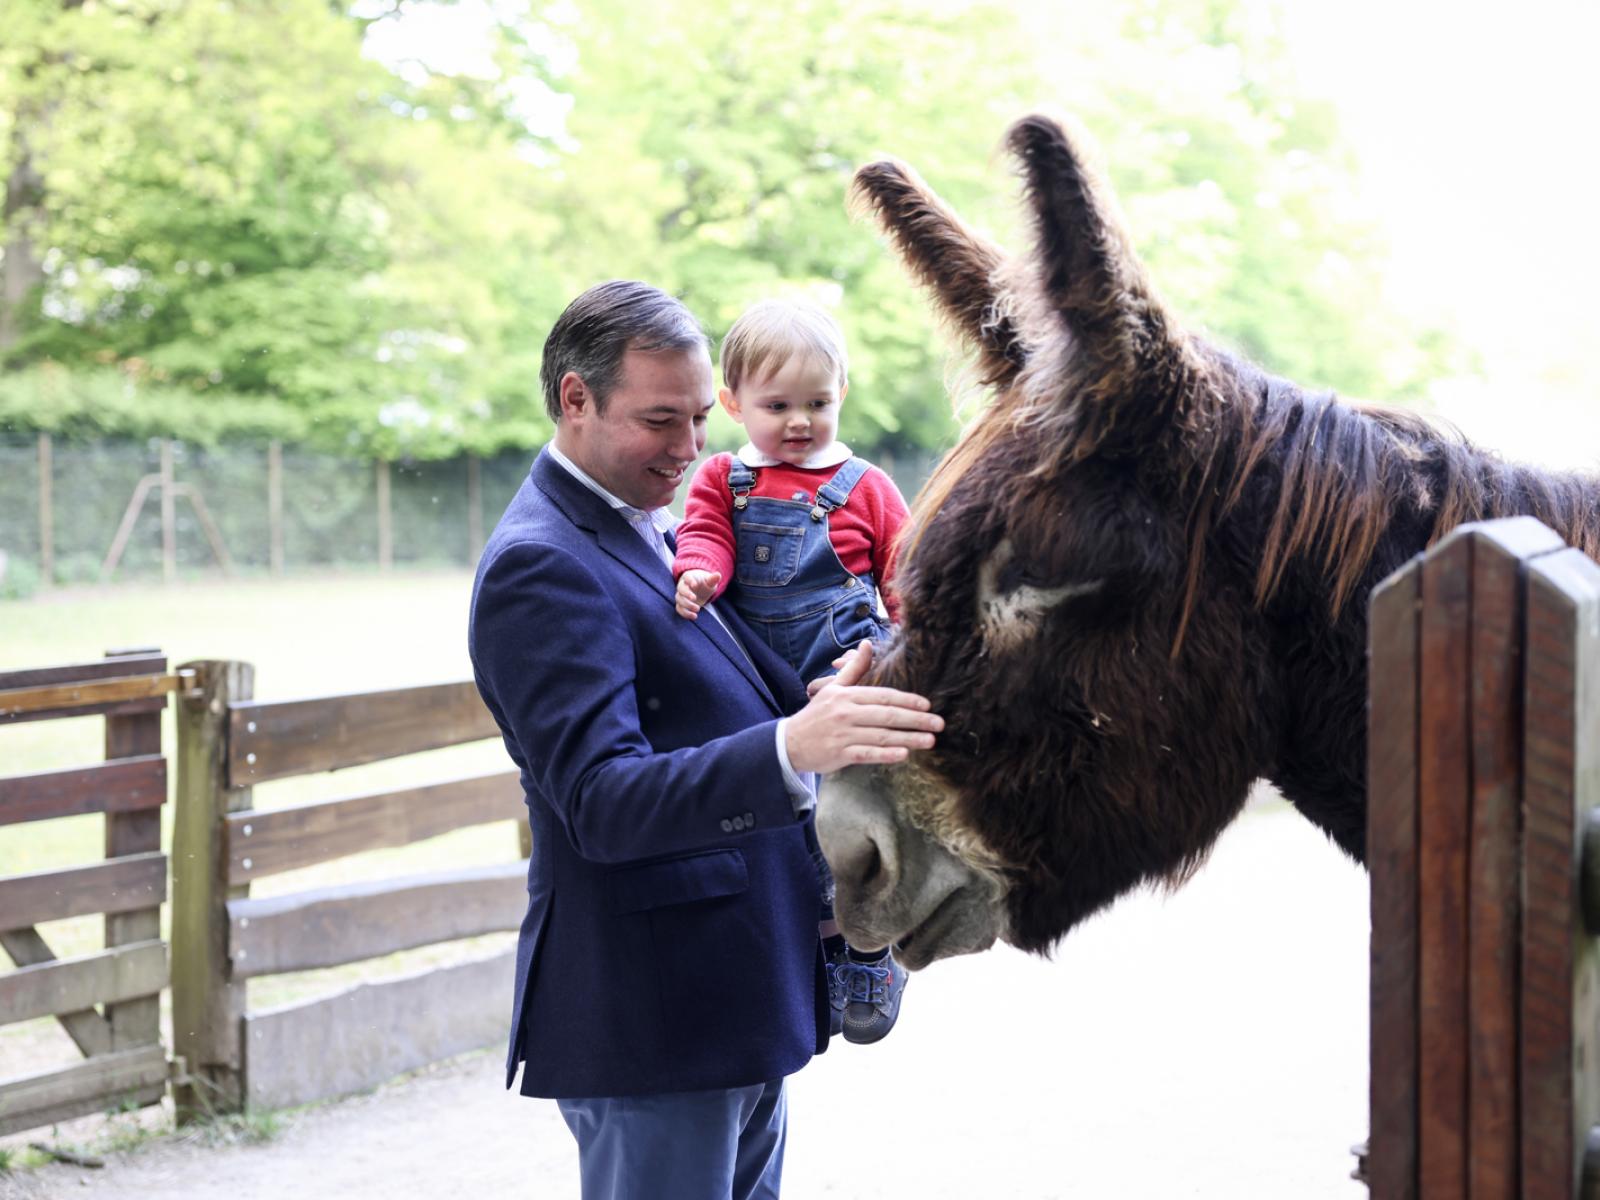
[557,347,712,509]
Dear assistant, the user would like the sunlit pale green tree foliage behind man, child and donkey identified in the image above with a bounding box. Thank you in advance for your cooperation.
[0,0,1450,458]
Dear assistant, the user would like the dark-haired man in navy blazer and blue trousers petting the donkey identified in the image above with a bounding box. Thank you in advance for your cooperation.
[469,282,942,1200]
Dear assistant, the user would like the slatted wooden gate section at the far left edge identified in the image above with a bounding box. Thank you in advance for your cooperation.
[0,651,187,1133]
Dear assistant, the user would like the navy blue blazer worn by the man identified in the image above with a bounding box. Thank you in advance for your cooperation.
[467,453,827,1098]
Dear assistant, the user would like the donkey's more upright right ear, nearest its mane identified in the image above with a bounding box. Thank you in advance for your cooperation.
[1006,117,1186,450]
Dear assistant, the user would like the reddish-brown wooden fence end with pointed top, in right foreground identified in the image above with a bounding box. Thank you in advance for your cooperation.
[1365,517,1600,1200]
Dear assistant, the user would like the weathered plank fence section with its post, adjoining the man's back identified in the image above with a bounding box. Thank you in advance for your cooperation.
[173,662,526,1112]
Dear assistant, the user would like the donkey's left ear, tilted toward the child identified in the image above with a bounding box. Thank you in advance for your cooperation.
[850,158,1024,387]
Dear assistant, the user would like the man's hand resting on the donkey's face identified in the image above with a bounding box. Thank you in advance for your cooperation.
[784,642,944,771]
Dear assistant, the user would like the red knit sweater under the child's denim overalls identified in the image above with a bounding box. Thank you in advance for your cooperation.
[672,454,907,621]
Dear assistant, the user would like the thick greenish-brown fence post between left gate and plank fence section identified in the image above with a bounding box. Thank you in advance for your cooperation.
[173,662,256,1122]
